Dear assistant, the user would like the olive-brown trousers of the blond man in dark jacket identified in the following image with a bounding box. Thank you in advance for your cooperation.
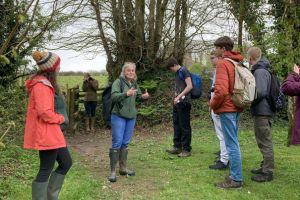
[254,116,274,173]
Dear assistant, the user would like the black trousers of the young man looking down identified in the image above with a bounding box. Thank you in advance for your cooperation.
[173,102,192,151]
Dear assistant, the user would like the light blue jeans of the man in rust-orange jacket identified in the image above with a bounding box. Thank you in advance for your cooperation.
[220,112,243,181]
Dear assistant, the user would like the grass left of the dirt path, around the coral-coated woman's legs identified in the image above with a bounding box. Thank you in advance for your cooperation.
[0,146,103,200]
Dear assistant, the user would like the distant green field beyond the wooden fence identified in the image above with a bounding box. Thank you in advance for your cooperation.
[58,75,108,90]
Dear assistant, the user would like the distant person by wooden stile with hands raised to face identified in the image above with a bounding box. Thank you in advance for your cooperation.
[82,73,98,132]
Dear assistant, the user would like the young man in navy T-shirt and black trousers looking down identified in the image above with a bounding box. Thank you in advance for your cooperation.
[165,58,193,157]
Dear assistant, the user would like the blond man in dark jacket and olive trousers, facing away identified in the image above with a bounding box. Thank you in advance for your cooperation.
[248,47,274,182]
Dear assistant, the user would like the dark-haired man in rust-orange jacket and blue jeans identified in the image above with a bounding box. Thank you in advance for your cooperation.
[210,36,243,189]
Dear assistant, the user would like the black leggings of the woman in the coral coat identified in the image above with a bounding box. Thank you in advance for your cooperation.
[35,147,72,182]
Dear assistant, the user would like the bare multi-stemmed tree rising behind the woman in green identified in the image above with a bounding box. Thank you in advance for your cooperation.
[59,0,225,80]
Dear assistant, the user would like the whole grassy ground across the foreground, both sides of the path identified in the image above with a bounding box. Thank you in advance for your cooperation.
[0,119,300,200]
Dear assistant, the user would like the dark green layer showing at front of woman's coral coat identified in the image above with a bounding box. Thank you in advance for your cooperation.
[54,93,69,131]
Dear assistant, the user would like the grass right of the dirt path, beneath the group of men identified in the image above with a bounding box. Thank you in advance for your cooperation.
[113,119,300,200]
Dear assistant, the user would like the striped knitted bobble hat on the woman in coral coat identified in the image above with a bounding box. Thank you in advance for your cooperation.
[32,51,60,72]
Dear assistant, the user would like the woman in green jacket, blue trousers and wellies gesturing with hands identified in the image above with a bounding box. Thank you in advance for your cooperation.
[108,62,149,182]
